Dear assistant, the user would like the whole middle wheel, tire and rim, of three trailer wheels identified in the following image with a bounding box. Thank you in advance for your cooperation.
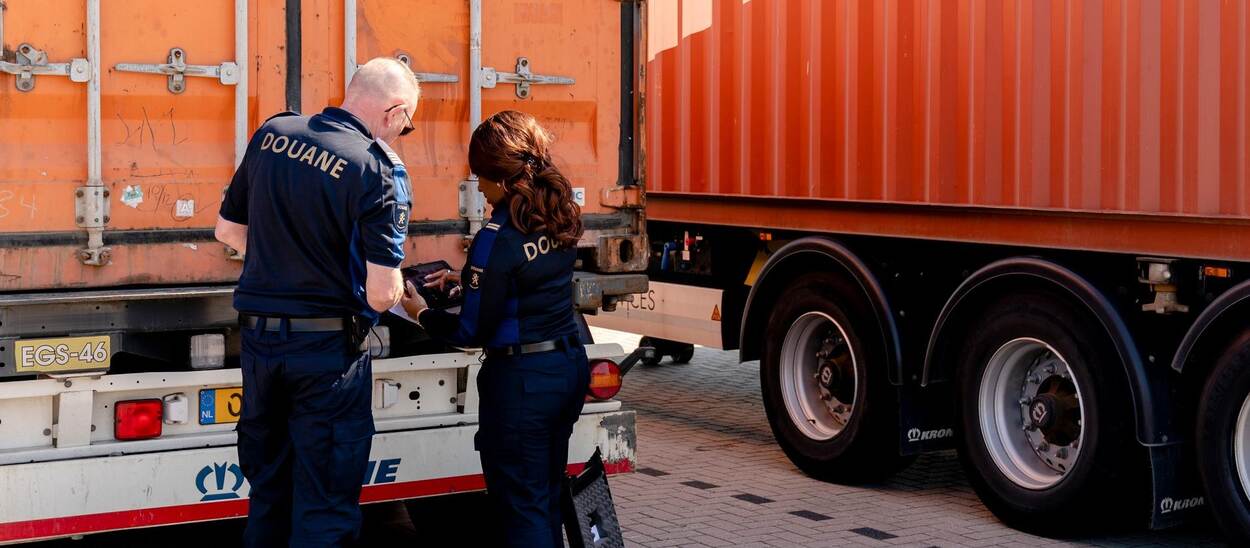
[956,294,1149,537]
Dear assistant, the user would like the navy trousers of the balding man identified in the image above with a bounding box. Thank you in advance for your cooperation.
[238,325,374,548]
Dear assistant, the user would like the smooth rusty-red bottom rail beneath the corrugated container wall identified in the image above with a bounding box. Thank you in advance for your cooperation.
[648,194,1250,261]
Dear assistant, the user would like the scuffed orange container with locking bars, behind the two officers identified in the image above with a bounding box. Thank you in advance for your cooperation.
[0,0,645,292]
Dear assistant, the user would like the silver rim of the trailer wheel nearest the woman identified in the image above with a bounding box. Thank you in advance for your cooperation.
[780,312,859,442]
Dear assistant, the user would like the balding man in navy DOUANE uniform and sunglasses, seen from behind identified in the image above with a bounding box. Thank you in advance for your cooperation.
[216,59,419,547]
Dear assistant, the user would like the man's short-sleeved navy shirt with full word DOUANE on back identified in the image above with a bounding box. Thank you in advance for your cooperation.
[221,106,411,319]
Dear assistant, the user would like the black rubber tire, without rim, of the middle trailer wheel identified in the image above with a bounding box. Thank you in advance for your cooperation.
[955,294,1150,537]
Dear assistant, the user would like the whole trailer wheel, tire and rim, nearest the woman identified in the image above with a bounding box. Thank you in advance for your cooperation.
[760,274,913,483]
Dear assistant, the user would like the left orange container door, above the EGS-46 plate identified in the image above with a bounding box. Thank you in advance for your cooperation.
[0,0,258,290]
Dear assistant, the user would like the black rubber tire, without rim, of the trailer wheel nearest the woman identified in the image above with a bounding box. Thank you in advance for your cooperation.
[760,274,915,484]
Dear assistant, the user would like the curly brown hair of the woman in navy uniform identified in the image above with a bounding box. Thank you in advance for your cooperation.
[469,110,583,246]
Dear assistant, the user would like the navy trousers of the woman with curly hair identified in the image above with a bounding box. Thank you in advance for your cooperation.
[476,344,590,548]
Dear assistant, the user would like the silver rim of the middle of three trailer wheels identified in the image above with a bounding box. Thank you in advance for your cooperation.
[978,338,1085,490]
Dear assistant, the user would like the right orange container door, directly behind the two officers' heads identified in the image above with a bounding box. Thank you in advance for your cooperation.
[340,0,633,240]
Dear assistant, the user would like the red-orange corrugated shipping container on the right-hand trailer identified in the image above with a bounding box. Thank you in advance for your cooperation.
[646,0,1250,259]
